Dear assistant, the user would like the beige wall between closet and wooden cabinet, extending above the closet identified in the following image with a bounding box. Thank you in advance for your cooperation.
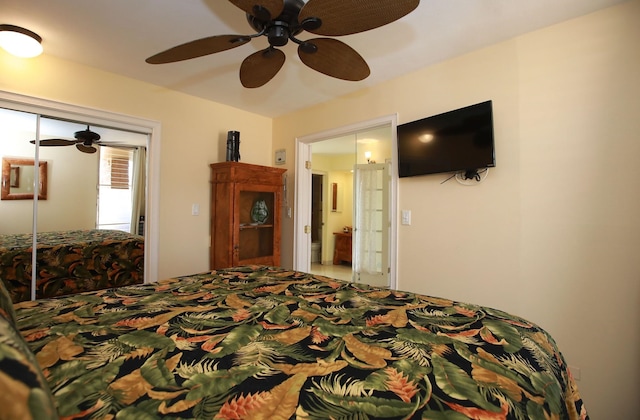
[0,50,273,278]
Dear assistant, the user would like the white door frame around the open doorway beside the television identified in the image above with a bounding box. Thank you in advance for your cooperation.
[293,114,398,289]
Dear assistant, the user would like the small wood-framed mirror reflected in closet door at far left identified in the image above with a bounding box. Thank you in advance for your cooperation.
[0,157,47,200]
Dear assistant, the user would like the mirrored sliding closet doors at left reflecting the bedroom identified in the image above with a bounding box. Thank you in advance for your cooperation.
[0,108,148,300]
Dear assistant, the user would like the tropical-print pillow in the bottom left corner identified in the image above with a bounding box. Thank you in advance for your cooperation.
[0,310,58,420]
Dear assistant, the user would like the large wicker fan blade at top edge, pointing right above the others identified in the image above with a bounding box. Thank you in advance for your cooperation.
[298,0,420,36]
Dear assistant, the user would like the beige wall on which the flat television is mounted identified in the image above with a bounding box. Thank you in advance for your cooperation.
[273,1,640,419]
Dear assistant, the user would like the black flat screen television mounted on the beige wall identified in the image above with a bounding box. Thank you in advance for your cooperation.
[398,101,496,178]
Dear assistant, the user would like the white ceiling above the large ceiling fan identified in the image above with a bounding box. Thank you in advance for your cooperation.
[0,0,623,117]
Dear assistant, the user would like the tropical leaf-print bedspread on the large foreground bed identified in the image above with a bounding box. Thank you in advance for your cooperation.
[16,267,587,420]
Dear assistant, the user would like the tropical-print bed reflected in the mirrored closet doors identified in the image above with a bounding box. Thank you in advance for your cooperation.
[0,229,144,302]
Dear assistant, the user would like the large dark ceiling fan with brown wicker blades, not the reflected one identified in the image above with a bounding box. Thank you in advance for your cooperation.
[145,0,420,88]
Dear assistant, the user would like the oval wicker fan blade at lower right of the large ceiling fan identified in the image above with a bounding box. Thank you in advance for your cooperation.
[298,38,371,82]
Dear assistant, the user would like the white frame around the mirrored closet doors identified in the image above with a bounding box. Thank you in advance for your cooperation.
[0,90,161,283]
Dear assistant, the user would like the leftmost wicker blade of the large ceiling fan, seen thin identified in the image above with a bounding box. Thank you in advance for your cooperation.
[145,35,251,64]
